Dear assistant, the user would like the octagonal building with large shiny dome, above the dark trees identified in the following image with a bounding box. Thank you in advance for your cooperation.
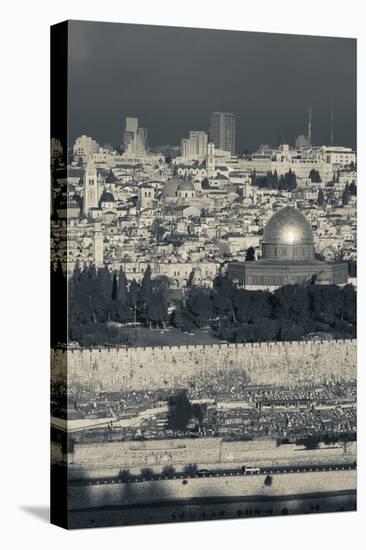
[228,206,348,290]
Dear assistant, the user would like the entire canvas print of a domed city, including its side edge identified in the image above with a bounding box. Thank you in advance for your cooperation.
[51,21,357,528]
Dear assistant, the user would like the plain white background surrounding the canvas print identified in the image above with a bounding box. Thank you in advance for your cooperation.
[0,0,366,550]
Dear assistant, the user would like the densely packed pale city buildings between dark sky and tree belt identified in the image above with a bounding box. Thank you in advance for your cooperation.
[51,113,357,289]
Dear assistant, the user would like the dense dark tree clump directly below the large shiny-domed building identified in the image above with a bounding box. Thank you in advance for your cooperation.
[176,276,356,342]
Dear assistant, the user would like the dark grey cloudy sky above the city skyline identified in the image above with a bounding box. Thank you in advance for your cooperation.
[69,21,356,151]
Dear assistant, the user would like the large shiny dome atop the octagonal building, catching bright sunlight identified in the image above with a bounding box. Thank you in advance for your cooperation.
[262,206,314,245]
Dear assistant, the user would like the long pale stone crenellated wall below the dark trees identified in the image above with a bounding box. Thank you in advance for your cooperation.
[51,340,357,391]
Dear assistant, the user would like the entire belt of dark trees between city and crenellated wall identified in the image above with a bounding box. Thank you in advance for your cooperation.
[51,258,356,345]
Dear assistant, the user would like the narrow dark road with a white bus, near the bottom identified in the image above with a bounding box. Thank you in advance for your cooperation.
[69,462,357,486]
